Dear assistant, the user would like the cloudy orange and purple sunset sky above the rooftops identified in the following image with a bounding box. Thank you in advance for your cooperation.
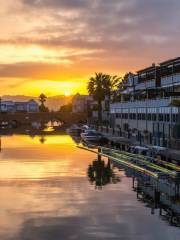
[0,0,180,96]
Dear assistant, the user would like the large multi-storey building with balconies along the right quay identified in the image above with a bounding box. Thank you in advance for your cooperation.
[110,58,180,149]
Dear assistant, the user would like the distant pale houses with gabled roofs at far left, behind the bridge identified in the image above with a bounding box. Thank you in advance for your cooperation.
[0,99,39,113]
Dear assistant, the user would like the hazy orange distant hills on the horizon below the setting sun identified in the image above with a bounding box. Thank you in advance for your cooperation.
[2,95,73,111]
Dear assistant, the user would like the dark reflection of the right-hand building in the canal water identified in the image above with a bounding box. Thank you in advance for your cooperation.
[114,163,180,227]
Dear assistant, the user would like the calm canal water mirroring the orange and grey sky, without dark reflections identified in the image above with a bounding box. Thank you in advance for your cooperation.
[0,136,180,240]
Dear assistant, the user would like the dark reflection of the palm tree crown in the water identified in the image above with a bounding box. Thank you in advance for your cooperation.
[88,159,120,189]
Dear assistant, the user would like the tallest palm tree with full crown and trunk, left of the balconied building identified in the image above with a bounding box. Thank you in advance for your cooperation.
[87,73,107,124]
